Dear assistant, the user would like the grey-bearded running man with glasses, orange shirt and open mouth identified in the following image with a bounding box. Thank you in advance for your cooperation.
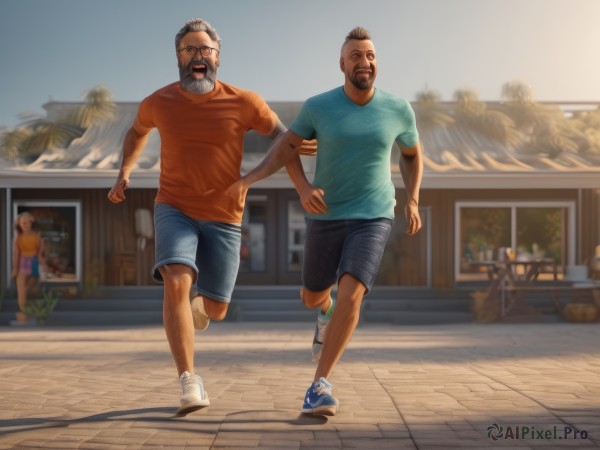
[108,19,316,415]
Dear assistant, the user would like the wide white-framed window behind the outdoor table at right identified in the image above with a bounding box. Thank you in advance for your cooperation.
[455,202,575,280]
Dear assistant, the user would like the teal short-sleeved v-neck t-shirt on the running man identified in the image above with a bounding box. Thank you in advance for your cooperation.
[290,86,419,220]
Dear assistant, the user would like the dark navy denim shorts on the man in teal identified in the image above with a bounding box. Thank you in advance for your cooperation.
[302,218,394,294]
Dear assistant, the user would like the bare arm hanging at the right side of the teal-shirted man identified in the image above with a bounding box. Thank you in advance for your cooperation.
[400,142,423,236]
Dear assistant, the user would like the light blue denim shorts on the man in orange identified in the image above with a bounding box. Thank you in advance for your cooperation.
[152,203,242,303]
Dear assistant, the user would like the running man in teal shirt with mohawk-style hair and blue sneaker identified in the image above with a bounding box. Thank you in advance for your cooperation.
[274,27,423,415]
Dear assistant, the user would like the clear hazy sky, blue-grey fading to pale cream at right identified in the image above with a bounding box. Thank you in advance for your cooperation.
[0,0,600,127]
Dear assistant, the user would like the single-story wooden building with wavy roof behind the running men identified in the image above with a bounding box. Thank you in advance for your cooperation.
[0,102,600,304]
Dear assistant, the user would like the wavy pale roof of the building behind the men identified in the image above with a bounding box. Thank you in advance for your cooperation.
[0,102,600,187]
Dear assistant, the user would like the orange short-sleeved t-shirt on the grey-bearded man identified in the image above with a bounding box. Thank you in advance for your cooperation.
[133,81,278,224]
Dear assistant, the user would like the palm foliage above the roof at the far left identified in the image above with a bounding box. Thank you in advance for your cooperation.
[0,86,116,163]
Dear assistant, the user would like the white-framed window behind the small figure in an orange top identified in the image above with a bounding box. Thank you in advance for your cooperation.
[13,201,81,282]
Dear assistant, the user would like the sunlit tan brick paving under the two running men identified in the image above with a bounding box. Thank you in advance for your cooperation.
[0,322,600,449]
